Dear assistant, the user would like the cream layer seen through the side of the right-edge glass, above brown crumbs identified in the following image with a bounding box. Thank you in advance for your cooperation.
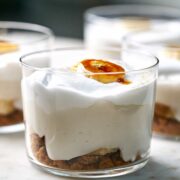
[156,73,180,122]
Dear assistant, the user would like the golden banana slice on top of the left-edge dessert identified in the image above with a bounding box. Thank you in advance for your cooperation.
[0,40,18,54]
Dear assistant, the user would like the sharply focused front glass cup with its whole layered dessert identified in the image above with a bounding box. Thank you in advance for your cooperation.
[20,48,158,178]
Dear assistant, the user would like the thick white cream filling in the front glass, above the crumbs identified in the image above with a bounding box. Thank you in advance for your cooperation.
[22,58,155,162]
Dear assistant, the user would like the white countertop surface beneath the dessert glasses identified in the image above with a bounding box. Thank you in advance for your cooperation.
[0,38,180,180]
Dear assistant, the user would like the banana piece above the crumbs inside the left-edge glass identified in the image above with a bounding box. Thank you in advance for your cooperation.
[0,100,15,116]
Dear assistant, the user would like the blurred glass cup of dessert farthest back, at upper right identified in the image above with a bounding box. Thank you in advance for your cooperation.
[84,4,180,49]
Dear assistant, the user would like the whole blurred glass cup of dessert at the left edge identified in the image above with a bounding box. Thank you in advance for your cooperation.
[0,21,53,133]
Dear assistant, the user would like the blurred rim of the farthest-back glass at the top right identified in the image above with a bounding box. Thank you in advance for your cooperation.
[84,4,180,21]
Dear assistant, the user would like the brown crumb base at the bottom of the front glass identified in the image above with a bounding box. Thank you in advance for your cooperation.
[31,134,140,170]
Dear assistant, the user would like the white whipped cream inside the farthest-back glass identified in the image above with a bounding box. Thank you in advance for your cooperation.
[85,18,167,48]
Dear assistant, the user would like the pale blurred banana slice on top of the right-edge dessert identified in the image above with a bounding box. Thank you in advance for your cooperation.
[164,44,180,60]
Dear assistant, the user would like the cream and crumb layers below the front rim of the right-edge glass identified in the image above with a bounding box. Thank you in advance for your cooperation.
[153,73,180,137]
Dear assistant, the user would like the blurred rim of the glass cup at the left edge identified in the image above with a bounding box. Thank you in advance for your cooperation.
[0,21,54,45]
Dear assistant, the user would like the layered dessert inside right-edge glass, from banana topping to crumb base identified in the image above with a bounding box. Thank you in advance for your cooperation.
[153,43,180,138]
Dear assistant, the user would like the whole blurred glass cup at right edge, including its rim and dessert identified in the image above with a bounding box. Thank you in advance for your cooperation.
[124,20,180,140]
